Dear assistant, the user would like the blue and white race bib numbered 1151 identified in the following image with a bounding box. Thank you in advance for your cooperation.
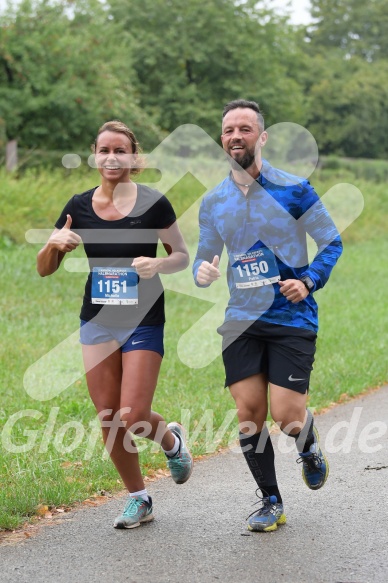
[92,267,139,305]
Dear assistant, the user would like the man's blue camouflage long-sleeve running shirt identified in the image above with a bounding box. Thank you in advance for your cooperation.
[193,160,342,332]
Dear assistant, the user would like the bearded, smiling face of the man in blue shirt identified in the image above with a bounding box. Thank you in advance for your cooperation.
[221,107,267,170]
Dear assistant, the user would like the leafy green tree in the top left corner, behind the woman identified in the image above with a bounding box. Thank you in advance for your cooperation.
[0,0,160,150]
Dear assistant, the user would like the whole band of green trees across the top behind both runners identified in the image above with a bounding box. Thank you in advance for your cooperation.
[0,0,388,158]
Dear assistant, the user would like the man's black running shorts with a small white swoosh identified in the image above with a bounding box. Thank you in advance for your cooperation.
[218,320,317,394]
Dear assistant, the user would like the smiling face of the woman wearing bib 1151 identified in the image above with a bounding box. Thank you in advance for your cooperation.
[95,130,133,183]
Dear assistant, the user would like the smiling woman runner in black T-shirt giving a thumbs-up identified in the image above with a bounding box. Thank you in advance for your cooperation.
[37,121,193,528]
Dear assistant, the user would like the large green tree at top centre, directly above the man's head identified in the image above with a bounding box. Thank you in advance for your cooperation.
[110,0,305,138]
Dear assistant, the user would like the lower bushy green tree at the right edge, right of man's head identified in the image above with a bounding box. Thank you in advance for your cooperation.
[309,55,388,158]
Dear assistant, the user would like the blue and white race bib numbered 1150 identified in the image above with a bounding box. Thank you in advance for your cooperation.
[230,247,280,288]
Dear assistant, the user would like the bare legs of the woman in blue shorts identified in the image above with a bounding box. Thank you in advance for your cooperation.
[82,341,183,492]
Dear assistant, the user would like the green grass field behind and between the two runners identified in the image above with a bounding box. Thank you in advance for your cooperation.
[0,160,388,529]
